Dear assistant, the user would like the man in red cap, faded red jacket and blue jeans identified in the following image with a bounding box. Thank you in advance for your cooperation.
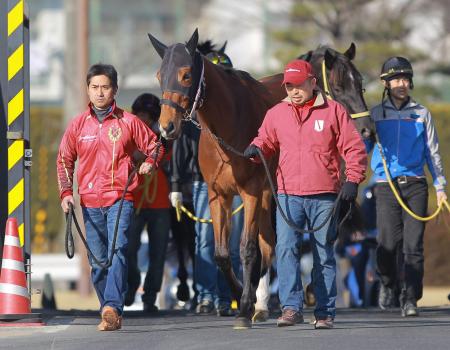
[245,60,367,329]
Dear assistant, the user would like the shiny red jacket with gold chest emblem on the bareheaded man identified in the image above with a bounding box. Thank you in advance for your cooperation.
[56,104,164,208]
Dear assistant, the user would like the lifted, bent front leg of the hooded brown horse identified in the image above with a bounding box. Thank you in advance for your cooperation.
[209,194,242,300]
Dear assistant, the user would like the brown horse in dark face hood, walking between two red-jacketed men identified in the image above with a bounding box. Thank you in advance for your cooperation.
[150,31,278,328]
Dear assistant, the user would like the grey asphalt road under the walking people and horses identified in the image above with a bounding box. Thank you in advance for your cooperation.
[0,307,450,350]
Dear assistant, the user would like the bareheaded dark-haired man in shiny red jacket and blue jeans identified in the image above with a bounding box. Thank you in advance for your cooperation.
[56,64,164,331]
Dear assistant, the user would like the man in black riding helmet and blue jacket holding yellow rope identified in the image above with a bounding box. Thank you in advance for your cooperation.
[368,57,447,317]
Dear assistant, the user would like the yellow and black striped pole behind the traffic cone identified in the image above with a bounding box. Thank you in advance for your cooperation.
[2,0,31,286]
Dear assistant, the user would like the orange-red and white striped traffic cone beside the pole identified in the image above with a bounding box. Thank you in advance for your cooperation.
[0,218,42,326]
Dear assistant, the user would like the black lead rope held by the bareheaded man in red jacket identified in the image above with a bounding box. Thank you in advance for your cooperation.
[65,142,161,270]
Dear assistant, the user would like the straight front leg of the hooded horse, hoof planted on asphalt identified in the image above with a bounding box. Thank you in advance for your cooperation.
[234,192,261,329]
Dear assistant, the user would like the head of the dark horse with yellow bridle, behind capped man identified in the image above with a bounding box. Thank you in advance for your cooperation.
[299,43,375,139]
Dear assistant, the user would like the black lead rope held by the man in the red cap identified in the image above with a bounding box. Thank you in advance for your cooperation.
[201,128,353,234]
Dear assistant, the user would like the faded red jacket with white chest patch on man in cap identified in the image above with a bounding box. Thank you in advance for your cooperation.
[252,94,367,195]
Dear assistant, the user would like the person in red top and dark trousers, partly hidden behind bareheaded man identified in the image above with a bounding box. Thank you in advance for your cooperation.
[125,93,170,312]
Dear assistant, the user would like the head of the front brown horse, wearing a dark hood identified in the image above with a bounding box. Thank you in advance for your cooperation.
[148,29,203,139]
